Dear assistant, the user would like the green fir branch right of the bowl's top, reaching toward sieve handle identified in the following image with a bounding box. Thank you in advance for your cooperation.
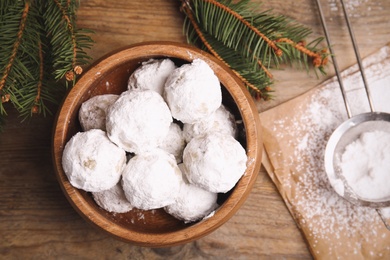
[181,0,328,99]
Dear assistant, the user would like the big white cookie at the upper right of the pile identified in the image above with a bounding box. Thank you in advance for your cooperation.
[164,59,222,124]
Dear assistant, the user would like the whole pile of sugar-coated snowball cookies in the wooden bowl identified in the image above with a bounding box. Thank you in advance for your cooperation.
[62,58,247,223]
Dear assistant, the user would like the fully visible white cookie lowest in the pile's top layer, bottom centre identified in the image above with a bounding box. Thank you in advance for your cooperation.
[122,148,183,210]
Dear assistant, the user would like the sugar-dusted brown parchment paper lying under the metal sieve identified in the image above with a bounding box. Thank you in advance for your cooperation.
[260,46,390,259]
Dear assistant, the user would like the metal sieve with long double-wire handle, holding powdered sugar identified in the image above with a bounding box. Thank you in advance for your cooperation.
[317,0,390,211]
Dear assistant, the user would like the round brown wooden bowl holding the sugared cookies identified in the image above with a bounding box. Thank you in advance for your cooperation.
[52,42,263,247]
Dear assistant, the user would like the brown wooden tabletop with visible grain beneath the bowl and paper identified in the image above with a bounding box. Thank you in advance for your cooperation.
[0,0,390,259]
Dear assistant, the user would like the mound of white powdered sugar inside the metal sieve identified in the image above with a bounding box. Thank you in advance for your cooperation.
[340,130,390,200]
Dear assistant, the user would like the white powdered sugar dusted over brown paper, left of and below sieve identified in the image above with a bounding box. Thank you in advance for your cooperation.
[270,82,390,258]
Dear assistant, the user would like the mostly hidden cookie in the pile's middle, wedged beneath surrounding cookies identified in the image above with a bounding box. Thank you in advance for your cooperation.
[160,123,186,163]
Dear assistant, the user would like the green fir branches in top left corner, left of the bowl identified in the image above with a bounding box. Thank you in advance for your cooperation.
[0,0,93,130]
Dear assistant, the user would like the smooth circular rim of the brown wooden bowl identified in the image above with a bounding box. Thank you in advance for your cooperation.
[52,41,263,247]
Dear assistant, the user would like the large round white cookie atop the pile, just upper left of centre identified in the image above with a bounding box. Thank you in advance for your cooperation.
[106,90,172,154]
